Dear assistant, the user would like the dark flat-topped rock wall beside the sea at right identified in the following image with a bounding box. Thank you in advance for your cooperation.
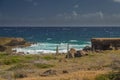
[91,38,120,50]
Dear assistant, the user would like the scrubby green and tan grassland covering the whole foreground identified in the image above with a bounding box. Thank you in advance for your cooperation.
[0,50,120,80]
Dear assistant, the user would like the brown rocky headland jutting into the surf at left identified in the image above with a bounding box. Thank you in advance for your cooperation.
[0,37,31,52]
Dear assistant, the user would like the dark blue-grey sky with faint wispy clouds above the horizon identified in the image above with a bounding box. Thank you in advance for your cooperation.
[0,0,120,26]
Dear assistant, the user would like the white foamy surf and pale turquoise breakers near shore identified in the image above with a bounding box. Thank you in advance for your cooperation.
[13,43,90,54]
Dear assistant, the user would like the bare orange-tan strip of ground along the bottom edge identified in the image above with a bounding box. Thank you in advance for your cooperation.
[18,71,106,80]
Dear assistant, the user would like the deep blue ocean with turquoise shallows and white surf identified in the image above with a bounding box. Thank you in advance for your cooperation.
[0,26,120,54]
